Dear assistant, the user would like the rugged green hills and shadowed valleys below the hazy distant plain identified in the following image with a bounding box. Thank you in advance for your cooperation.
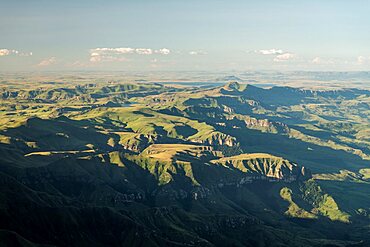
[0,78,370,246]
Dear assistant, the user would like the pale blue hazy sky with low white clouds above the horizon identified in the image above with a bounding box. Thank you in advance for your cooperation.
[0,0,370,72]
